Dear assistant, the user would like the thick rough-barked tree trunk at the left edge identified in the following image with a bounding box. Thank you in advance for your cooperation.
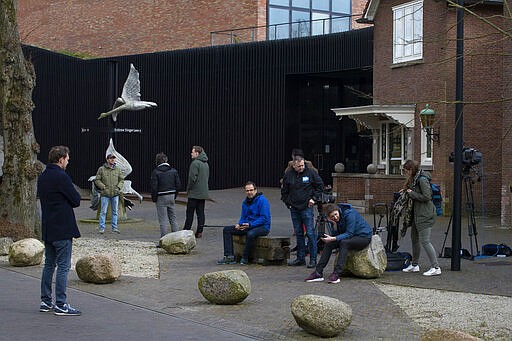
[0,0,42,237]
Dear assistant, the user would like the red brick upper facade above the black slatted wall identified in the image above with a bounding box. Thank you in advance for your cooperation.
[18,0,367,57]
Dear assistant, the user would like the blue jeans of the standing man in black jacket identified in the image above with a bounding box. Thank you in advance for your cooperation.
[290,207,317,261]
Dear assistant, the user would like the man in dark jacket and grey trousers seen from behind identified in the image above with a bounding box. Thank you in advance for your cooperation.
[151,153,181,238]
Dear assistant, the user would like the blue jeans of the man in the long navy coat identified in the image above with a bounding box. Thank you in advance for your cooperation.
[41,239,73,307]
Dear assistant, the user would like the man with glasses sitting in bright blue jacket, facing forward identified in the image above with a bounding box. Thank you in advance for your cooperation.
[217,181,270,265]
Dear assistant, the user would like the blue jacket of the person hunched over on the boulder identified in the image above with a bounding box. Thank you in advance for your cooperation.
[336,204,373,241]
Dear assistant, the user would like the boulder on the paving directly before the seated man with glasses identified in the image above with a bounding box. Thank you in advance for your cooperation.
[198,270,251,304]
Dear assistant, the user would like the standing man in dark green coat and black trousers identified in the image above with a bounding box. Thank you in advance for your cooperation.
[183,146,210,238]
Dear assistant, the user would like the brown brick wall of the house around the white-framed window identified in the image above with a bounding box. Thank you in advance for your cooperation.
[373,0,506,215]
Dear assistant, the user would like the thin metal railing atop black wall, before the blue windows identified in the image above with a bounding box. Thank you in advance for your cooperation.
[210,15,354,46]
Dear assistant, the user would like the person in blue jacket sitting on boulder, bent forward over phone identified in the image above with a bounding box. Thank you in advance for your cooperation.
[305,204,372,283]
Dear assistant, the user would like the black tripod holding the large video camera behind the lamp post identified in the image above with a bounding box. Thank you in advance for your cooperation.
[439,166,480,260]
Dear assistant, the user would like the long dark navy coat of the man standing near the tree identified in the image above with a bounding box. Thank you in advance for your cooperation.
[37,163,80,242]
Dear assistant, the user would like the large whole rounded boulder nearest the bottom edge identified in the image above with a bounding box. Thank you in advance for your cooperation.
[291,295,352,337]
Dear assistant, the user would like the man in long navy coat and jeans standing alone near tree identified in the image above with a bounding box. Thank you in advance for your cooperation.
[37,146,81,315]
